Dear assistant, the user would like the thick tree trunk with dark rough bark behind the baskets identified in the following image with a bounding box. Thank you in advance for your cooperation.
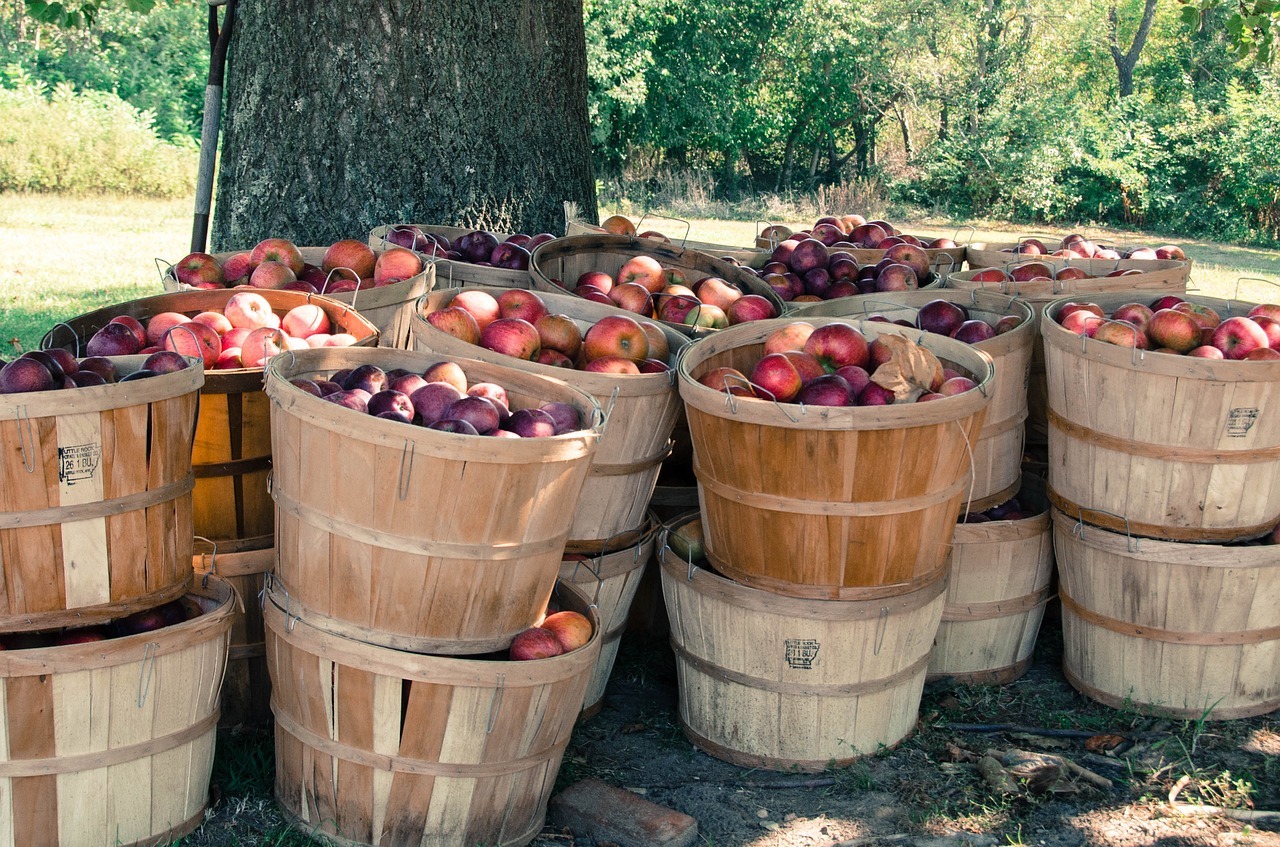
[212,0,596,249]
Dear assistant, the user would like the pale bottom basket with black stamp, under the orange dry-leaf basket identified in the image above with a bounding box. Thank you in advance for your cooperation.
[662,516,946,772]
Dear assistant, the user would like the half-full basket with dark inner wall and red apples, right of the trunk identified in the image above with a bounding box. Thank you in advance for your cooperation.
[530,234,785,338]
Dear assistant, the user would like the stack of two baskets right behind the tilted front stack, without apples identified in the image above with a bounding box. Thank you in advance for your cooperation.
[412,287,689,716]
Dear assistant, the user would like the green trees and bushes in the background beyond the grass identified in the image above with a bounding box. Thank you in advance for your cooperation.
[0,0,1280,244]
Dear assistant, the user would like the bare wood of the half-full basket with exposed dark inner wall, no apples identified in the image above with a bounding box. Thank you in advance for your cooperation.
[529,233,787,338]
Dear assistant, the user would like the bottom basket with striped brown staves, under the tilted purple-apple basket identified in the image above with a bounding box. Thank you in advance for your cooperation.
[265,583,602,847]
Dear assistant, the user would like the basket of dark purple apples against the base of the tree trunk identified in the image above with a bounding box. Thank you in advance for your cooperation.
[369,224,556,288]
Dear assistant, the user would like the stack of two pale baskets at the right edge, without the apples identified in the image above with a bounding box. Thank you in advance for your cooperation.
[1042,294,1280,719]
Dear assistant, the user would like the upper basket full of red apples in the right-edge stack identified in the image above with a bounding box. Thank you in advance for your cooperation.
[1041,292,1280,541]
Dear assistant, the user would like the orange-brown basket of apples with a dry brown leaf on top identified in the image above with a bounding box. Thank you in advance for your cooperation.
[678,317,995,600]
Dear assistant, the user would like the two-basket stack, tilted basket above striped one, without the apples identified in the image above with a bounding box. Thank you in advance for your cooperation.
[265,348,603,847]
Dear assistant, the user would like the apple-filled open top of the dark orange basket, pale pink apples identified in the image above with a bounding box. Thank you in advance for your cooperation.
[41,288,379,376]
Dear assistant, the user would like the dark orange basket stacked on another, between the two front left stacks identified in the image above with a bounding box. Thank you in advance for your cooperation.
[44,287,379,727]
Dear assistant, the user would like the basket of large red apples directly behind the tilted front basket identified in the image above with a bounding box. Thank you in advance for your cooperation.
[412,288,690,551]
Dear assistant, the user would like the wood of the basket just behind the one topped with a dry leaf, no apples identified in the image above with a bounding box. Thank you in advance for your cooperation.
[788,290,1037,512]
